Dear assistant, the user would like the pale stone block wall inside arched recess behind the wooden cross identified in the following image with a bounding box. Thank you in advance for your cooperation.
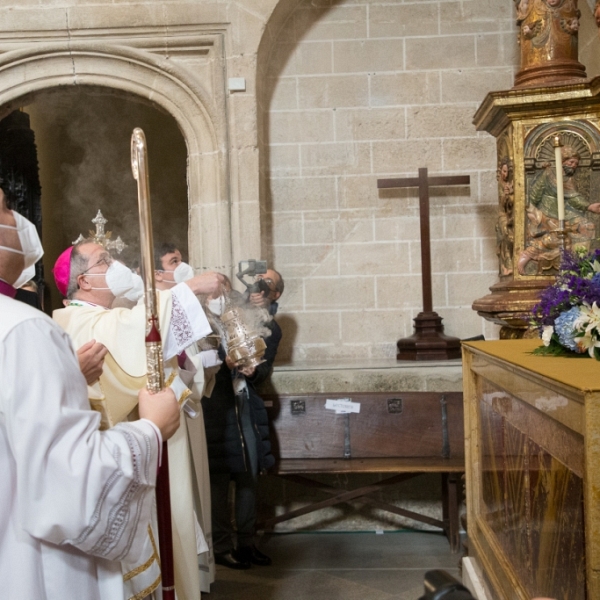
[260,0,597,361]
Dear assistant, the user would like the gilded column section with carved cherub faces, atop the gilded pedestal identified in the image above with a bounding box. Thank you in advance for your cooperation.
[515,0,585,86]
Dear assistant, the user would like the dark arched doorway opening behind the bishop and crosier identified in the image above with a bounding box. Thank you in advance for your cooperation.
[15,86,188,308]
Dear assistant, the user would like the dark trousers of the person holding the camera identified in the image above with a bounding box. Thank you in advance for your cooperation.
[210,473,256,554]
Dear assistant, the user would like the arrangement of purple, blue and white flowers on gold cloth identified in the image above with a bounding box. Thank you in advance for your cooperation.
[532,249,600,360]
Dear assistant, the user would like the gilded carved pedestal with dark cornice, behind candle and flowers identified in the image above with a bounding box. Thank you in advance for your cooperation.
[473,78,600,339]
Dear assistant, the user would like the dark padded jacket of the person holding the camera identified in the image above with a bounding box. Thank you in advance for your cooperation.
[202,320,281,473]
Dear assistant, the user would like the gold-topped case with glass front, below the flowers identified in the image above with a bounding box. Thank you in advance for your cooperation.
[463,340,600,600]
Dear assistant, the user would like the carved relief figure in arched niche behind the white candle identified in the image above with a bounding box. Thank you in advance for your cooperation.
[517,132,600,275]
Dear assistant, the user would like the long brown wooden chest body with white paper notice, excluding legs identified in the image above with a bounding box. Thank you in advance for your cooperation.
[264,392,464,460]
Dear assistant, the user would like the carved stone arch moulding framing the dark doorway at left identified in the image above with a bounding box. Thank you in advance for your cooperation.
[0,41,231,274]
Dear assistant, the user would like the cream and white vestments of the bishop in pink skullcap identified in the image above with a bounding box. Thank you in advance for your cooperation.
[53,284,212,600]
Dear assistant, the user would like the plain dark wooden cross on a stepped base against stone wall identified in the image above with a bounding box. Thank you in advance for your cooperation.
[377,167,471,360]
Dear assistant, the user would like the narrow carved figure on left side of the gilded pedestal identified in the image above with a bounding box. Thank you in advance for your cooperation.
[496,156,515,277]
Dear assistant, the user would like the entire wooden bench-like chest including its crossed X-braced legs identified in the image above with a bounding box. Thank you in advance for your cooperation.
[258,392,465,552]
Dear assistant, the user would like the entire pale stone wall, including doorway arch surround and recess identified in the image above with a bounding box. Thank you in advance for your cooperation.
[0,0,600,362]
